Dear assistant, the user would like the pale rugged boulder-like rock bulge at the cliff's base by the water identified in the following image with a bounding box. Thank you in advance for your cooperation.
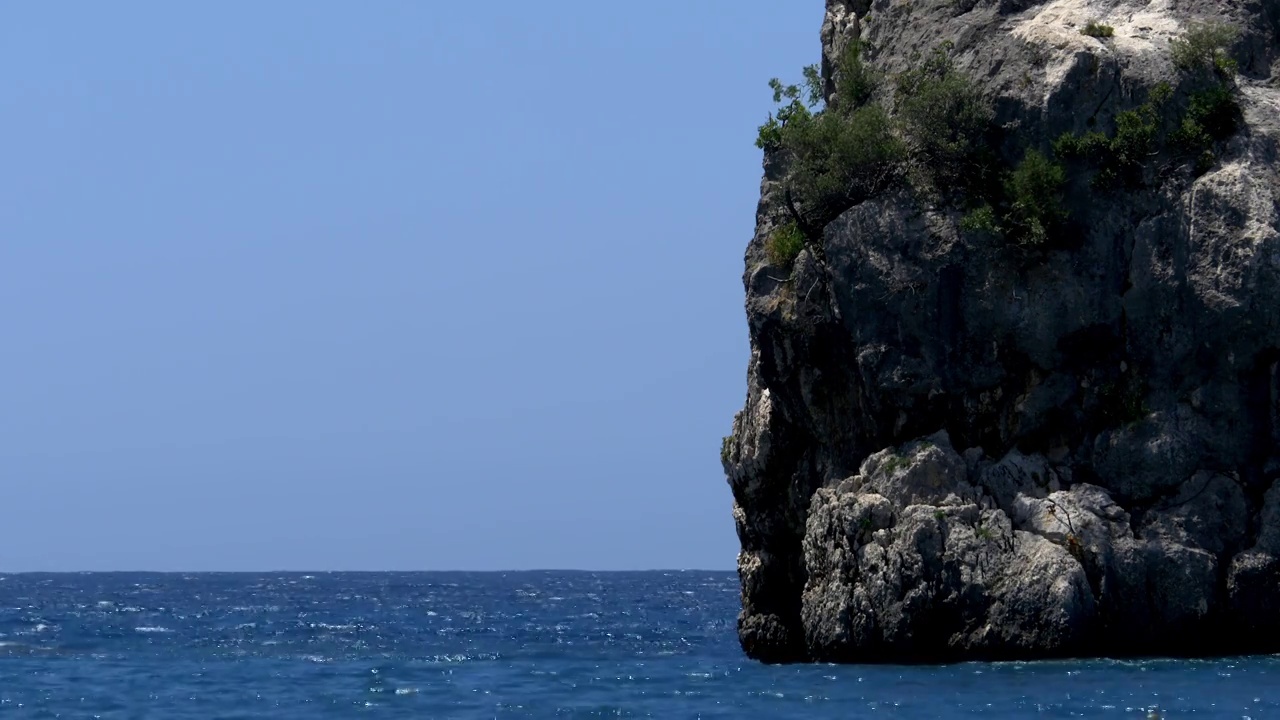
[801,436,1094,661]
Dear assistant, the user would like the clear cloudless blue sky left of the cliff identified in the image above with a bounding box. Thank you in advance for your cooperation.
[0,0,822,571]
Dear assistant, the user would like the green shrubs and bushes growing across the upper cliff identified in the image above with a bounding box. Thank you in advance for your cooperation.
[756,20,1240,258]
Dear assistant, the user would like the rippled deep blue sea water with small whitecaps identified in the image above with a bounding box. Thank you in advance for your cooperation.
[0,573,1280,720]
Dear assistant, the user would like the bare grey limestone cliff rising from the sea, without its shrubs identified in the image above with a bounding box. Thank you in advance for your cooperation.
[723,0,1280,662]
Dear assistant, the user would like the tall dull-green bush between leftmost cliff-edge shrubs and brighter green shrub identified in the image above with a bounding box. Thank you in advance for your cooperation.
[895,46,995,190]
